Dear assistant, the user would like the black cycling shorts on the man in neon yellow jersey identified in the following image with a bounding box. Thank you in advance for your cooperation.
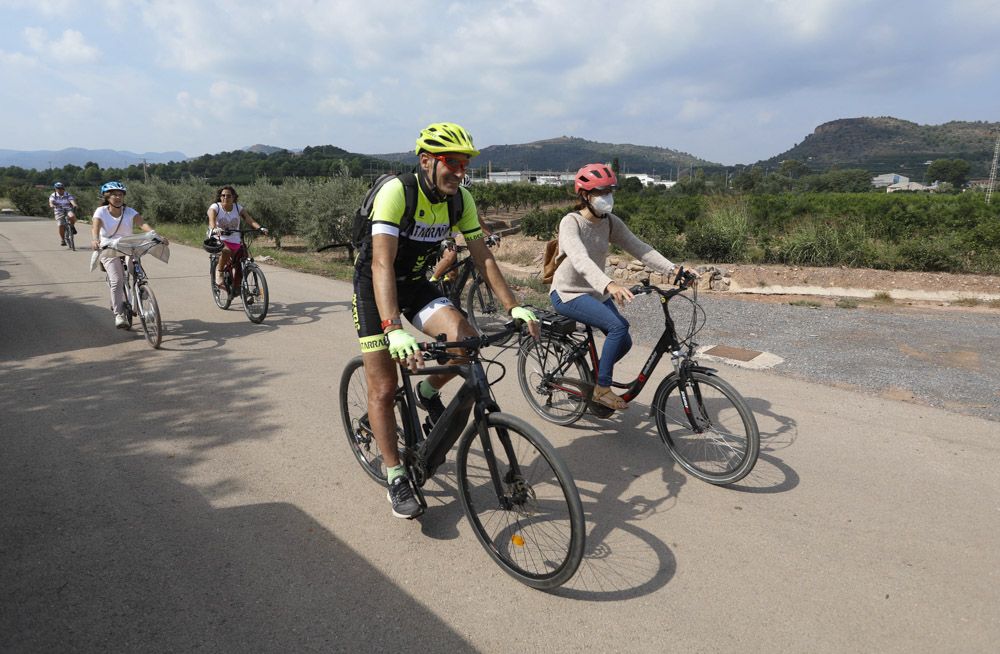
[351,270,453,353]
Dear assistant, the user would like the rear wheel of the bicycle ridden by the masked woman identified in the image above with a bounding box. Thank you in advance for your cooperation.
[517,333,594,425]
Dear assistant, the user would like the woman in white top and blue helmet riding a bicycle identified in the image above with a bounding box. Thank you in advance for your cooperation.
[90,182,167,329]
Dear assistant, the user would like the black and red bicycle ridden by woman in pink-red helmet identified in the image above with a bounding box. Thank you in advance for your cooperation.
[517,269,760,484]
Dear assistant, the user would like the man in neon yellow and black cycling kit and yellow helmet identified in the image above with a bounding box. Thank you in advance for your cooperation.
[353,123,539,519]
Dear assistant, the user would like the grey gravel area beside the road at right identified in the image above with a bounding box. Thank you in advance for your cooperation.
[623,295,1000,421]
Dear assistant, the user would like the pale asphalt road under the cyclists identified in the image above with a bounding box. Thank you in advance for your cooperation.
[0,218,1000,652]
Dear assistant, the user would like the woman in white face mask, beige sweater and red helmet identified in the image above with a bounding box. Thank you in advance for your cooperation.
[549,164,696,409]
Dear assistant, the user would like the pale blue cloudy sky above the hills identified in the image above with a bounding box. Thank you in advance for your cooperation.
[0,0,1000,164]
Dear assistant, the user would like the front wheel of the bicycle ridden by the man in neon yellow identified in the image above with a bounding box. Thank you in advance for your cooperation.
[456,413,586,590]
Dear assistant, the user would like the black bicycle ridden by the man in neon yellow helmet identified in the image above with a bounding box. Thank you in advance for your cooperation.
[340,324,585,590]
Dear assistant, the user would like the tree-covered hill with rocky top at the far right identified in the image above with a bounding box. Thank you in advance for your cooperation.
[761,116,1000,179]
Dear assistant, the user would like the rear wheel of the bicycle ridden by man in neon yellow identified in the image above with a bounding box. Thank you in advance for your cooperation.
[340,356,407,485]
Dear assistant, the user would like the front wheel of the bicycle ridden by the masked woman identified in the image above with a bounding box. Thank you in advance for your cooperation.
[653,370,760,485]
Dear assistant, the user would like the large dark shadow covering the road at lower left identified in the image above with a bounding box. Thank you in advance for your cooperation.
[0,310,471,651]
